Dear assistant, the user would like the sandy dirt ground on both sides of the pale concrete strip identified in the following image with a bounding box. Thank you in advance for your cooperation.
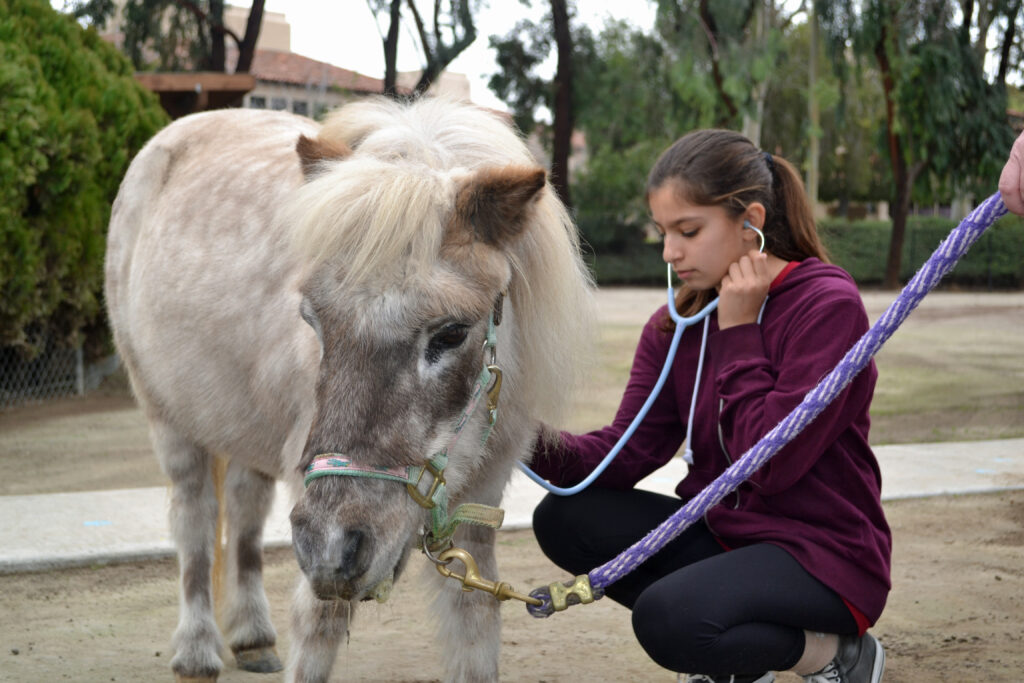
[0,292,1024,683]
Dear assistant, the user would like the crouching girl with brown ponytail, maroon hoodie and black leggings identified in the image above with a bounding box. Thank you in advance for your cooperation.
[532,130,892,683]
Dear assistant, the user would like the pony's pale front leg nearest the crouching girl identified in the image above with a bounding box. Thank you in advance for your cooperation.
[433,524,502,683]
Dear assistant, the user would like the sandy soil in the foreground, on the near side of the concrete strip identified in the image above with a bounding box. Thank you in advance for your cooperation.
[0,492,1024,683]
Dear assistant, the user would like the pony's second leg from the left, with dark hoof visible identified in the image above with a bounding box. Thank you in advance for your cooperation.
[223,460,282,674]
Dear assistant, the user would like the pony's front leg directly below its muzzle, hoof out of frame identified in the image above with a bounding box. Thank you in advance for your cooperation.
[285,577,354,683]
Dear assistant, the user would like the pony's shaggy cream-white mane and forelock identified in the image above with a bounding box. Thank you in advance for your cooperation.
[286,98,594,422]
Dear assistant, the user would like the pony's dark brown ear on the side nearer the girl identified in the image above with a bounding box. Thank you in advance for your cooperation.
[455,166,545,247]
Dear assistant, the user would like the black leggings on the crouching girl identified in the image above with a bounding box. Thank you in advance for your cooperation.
[534,487,857,675]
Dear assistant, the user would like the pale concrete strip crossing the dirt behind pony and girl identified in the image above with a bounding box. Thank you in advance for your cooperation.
[0,439,1024,573]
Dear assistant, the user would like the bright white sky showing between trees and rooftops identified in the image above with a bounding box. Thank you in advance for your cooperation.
[231,0,654,110]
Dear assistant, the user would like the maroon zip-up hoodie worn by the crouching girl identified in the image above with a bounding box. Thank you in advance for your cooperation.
[532,258,892,624]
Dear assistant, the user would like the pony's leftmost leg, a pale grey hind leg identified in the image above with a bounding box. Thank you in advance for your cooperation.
[151,421,222,681]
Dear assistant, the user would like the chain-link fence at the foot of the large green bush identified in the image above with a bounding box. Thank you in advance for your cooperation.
[0,348,86,411]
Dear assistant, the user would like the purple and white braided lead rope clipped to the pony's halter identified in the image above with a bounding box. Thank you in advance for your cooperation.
[527,195,1007,617]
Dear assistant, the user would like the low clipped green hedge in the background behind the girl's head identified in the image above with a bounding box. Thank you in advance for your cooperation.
[585,216,1024,289]
